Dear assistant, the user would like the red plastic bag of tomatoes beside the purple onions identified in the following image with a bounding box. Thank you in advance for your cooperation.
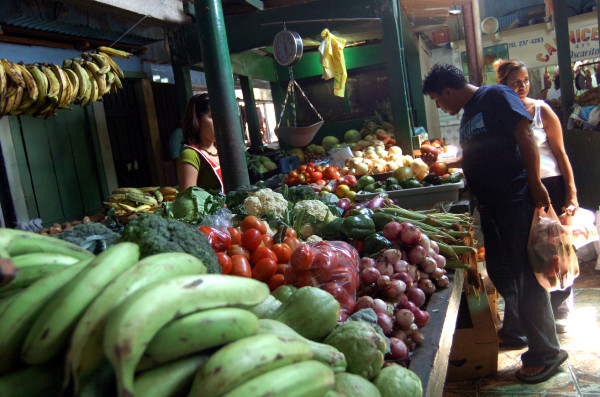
[285,241,360,321]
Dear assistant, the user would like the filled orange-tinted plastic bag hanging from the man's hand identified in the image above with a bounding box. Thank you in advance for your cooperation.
[527,207,579,292]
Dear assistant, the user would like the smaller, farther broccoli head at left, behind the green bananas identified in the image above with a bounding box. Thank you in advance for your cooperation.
[54,222,119,255]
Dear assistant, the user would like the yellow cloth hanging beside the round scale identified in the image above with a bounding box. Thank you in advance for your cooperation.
[319,29,348,98]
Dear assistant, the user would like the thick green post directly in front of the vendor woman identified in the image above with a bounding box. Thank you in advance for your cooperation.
[194,0,250,192]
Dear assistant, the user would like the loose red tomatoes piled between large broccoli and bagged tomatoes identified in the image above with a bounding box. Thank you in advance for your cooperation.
[199,215,301,291]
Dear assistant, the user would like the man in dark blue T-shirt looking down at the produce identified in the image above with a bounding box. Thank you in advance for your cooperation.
[423,64,568,383]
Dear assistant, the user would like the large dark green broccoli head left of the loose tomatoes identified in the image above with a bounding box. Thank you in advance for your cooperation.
[119,214,221,273]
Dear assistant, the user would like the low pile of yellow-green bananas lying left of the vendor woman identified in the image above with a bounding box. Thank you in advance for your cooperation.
[103,186,178,215]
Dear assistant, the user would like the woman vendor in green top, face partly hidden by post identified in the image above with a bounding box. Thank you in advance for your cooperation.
[177,94,224,192]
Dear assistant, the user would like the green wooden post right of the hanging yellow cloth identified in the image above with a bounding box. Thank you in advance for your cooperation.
[380,0,413,156]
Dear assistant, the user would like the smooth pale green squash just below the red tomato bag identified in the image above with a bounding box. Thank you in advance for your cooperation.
[272,287,340,341]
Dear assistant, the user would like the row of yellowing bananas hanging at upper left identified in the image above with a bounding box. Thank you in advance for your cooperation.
[0,47,132,118]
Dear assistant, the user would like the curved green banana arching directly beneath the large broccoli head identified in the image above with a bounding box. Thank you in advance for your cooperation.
[65,252,206,394]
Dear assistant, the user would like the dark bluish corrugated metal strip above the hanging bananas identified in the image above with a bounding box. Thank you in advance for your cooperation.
[3,16,162,46]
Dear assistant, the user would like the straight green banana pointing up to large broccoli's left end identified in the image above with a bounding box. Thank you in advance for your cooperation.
[21,243,140,365]
